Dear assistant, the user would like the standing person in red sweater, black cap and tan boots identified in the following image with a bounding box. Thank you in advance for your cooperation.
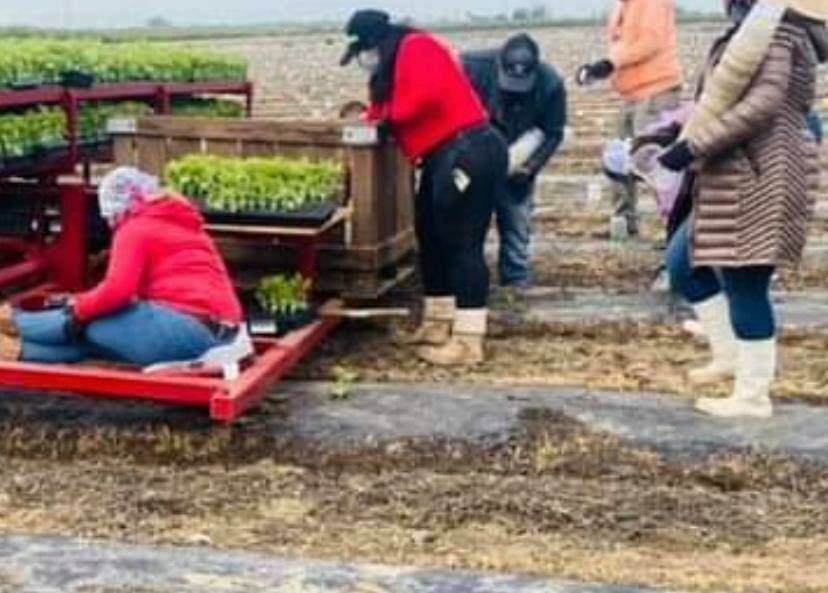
[342,10,508,365]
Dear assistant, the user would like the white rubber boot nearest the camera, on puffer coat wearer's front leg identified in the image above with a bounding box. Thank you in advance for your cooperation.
[696,338,776,418]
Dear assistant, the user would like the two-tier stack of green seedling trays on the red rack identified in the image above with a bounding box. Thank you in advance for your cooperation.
[0,39,252,177]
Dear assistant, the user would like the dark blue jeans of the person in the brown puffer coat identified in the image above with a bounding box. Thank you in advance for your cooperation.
[667,220,776,340]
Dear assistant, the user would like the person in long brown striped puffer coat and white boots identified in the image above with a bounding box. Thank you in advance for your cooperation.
[660,0,828,417]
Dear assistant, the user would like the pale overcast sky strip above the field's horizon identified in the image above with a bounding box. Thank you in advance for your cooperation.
[0,0,721,27]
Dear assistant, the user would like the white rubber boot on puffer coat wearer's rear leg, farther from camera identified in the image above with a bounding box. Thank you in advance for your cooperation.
[687,294,737,385]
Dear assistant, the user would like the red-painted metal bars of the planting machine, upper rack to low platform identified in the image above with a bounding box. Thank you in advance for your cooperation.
[0,83,348,422]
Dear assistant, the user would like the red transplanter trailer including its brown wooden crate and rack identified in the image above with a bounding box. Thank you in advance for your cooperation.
[0,83,413,422]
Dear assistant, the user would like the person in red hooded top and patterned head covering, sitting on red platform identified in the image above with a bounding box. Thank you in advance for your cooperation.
[0,167,249,367]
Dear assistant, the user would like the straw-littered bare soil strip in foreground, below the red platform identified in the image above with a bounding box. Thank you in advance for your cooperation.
[0,410,828,593]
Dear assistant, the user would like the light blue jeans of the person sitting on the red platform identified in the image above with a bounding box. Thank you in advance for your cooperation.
[15,302,220,366]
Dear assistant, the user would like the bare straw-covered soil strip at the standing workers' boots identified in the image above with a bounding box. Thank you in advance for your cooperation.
[297,322,828,403]
